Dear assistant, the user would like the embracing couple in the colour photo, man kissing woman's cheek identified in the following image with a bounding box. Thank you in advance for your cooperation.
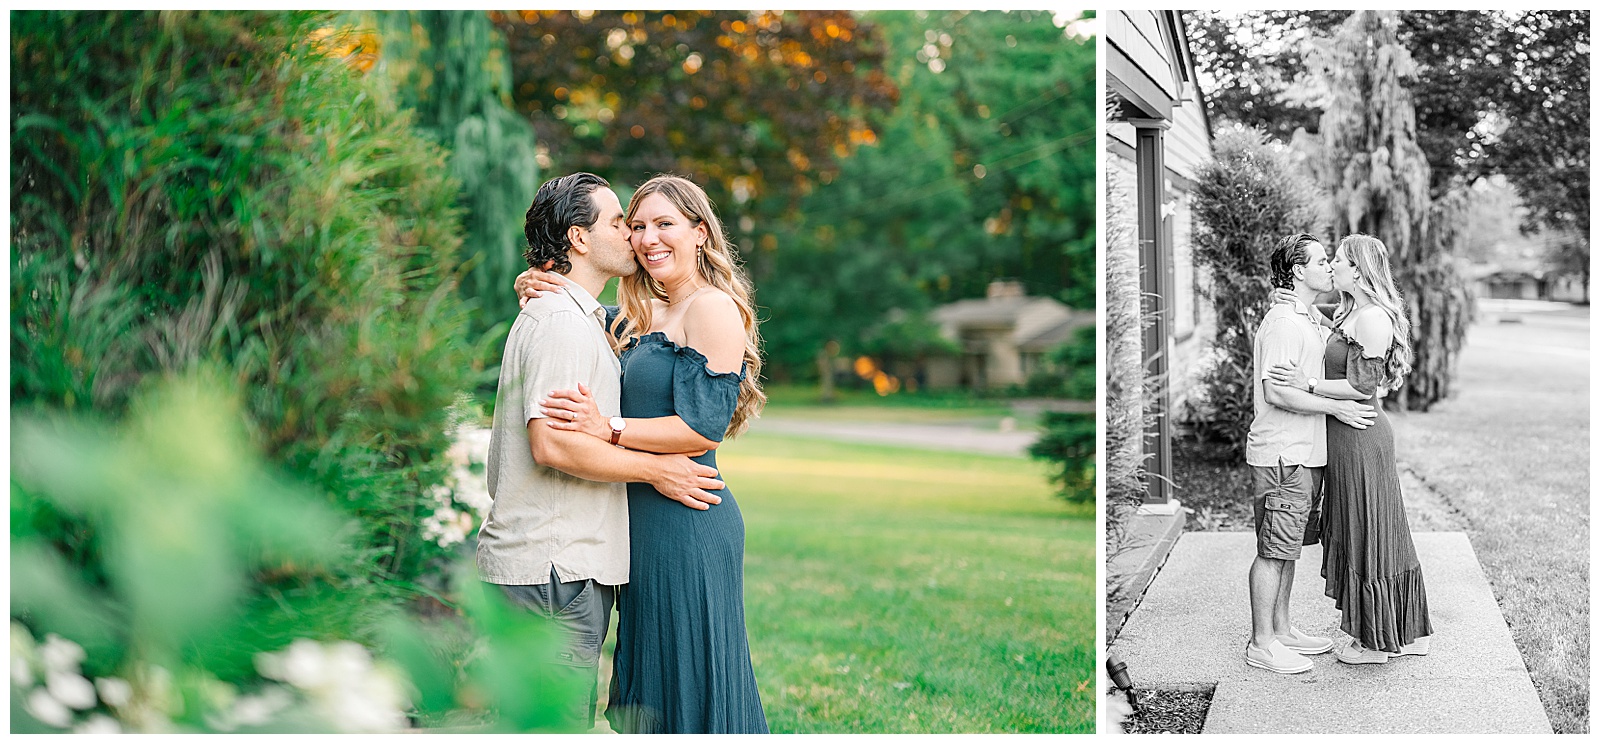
[477,173,766,733]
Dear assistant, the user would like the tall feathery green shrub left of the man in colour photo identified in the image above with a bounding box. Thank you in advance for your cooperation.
[11,11,470,592]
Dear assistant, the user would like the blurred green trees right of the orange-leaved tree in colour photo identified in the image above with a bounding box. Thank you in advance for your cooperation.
[747,11,1094,382]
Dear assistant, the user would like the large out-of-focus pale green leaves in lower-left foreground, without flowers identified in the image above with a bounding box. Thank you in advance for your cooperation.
[10,376,356,726]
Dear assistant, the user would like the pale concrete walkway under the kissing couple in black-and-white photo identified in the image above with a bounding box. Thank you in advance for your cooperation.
[1112,533,1550,734]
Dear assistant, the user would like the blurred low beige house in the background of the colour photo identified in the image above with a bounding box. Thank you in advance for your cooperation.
[923,282,1094,390]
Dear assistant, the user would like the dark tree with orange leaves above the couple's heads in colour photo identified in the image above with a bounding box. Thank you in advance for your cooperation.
[490,11,898,210]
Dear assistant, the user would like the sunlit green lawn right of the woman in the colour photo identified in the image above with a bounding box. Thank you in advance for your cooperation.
[717,432,1096,733]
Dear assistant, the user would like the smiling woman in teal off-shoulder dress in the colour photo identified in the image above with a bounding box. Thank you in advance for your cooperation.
[518,176,766,733]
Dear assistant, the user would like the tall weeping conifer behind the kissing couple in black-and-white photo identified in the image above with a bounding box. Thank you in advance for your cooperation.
[1296,11,1472,411]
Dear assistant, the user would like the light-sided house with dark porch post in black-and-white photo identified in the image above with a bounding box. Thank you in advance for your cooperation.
[1104,10,1214,507]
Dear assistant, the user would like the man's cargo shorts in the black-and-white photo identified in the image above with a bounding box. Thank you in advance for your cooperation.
[1250,461,1322,560]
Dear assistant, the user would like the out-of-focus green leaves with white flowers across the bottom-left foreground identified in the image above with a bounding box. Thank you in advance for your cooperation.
[10,371,581,731]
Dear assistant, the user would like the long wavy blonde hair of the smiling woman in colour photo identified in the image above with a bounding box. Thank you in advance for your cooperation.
[616,176,766,437]
